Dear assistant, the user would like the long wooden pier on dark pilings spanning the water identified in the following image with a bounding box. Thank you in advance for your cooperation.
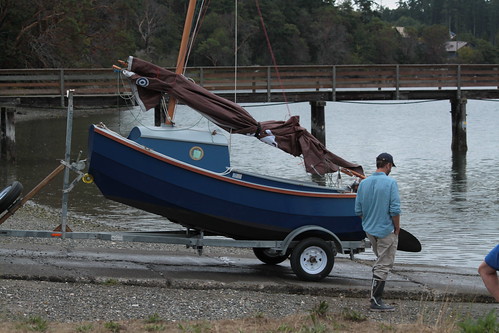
[0,64,499,160]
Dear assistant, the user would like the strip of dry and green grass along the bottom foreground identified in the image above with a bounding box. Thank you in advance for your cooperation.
[0,301,499,333]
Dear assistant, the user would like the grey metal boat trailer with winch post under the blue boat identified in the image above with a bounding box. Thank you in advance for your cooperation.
[0,90,369,281]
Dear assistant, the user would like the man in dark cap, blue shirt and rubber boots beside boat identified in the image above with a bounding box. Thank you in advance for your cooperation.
[355,153,401,311]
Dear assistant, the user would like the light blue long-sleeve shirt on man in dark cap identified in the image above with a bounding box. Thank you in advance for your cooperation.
[355,172,401,238]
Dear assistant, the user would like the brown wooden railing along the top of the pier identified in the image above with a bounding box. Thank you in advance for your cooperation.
[0,64,499,98]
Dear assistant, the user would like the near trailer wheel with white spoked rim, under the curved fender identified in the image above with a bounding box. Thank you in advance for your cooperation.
[291,237,334,281]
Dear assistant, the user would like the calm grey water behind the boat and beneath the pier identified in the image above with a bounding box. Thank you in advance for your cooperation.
[0,100,499,267]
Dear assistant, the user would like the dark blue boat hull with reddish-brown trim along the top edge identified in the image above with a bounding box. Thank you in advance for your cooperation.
[89,126,365,240]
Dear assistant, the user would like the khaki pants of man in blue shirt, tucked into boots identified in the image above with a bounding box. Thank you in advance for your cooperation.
[366,232,399,281]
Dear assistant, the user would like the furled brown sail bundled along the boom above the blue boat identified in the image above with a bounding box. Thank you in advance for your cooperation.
[123,57,364,175]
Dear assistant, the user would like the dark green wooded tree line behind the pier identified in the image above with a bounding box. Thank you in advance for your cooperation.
[0,0,499,68]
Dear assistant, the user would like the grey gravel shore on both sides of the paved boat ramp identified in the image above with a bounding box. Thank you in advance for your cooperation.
[0,202,495,324]
